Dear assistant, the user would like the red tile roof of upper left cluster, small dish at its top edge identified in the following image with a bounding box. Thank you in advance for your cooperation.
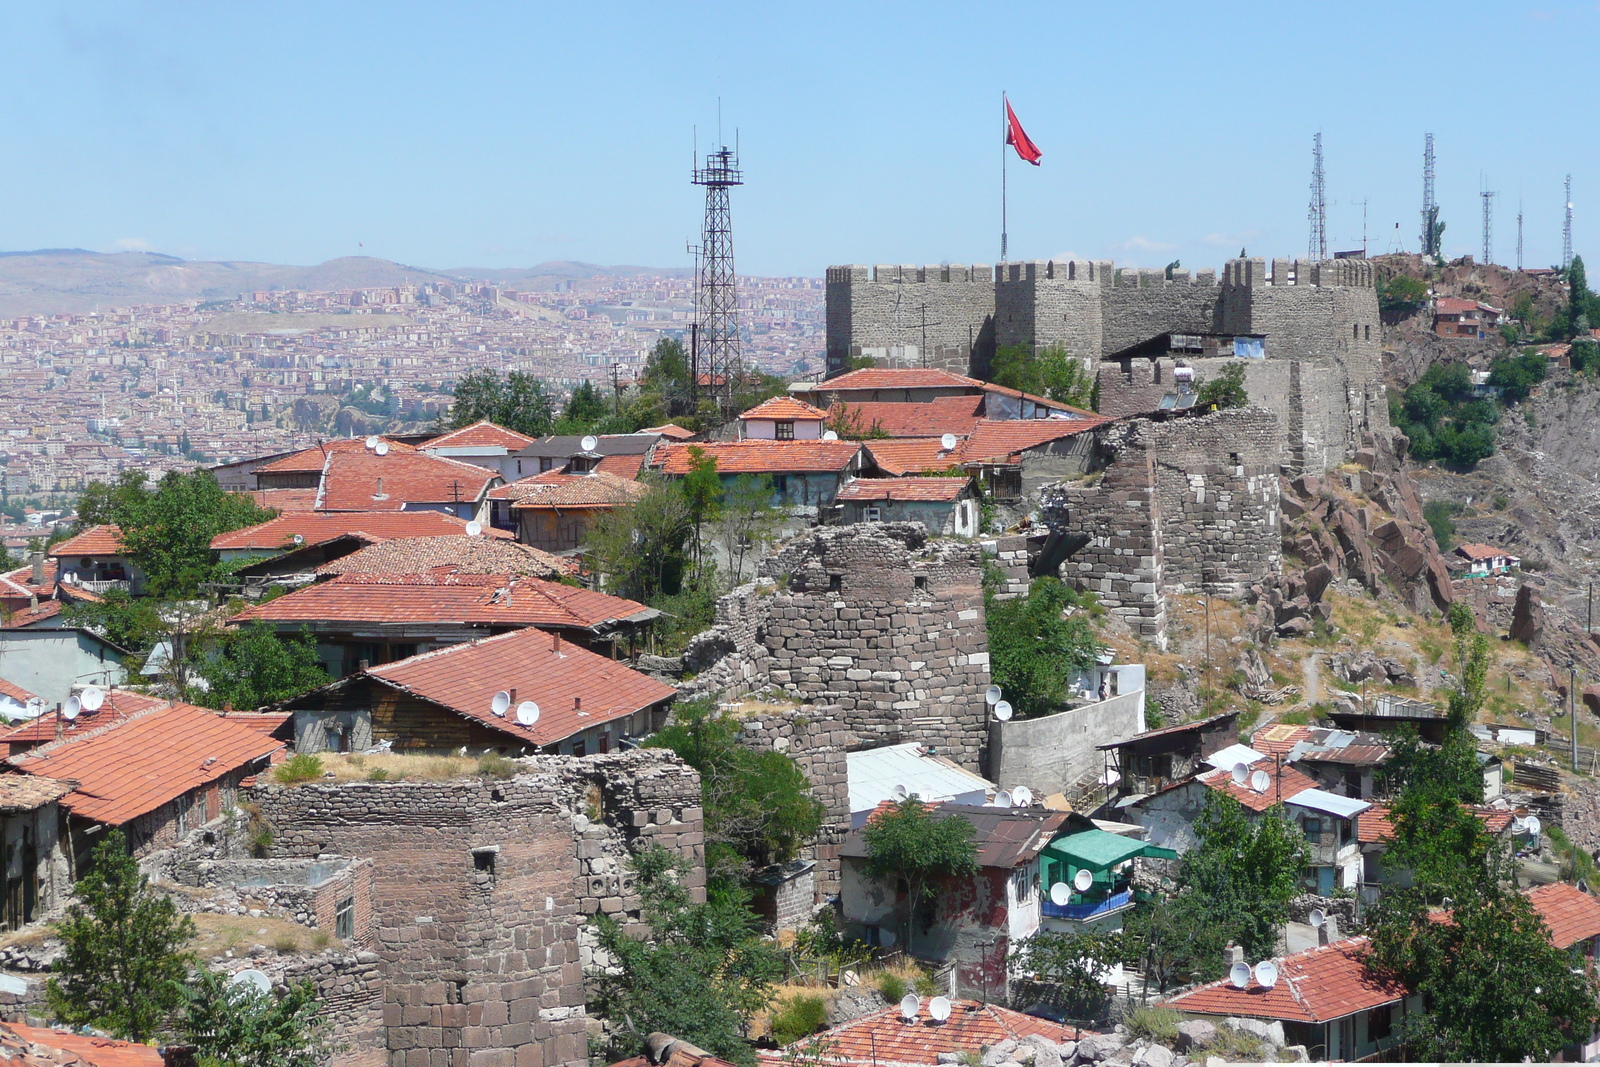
[308,448,499,512]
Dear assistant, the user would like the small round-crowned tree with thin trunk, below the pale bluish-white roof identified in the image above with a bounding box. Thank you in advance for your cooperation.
[864,797,978,949]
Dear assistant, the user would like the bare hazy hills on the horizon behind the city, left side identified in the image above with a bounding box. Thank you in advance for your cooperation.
[0,248,688,315]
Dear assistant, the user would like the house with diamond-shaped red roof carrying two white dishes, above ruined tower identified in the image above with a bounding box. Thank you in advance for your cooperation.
[275,630,677,755]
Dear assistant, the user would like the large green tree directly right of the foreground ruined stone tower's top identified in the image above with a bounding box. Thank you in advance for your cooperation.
[646,699,824,883]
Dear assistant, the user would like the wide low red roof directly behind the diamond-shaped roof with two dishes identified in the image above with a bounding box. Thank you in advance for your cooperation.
[232,574,654,630]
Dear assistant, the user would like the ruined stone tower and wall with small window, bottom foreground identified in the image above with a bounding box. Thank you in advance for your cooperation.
[244,750,704,1067]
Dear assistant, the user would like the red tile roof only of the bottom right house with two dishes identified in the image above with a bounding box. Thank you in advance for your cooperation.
[1160,937,1406,1022]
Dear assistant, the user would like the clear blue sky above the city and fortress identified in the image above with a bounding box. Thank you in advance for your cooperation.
[0,0,1600,275]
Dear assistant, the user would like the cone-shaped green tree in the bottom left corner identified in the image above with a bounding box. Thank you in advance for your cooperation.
[45,830,195,1041]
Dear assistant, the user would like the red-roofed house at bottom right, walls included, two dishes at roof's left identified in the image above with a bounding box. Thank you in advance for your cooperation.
[1160,937,1422,1062]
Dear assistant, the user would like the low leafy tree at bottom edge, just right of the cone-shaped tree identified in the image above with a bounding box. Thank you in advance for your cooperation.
[179,968,333,1067]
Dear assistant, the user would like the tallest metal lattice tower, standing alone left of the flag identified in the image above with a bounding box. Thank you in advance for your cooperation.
[691,146,744,410]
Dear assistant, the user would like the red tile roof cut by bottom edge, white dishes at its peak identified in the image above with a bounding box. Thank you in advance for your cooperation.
[760,997,1091,1067]
